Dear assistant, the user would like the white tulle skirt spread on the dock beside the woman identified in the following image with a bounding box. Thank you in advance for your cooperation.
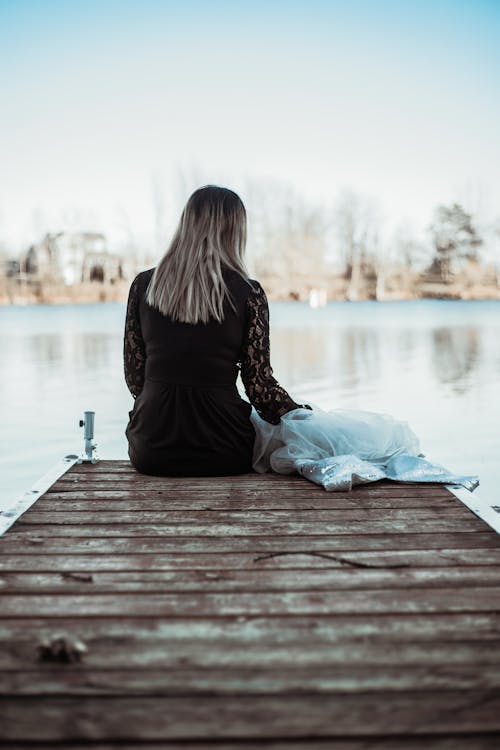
[251,406,479,492]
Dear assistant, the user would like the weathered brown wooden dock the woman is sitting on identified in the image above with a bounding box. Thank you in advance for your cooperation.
[0,461,500,750]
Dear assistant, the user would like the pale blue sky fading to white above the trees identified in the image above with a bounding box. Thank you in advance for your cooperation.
[0,0,500,251]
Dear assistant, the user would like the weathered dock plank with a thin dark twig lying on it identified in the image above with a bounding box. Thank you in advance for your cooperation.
[0,545,500,574]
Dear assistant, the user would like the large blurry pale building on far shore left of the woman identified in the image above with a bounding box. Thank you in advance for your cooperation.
[24,232,123,285]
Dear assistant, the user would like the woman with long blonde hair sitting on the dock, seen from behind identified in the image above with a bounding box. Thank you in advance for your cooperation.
[124,185,310,476]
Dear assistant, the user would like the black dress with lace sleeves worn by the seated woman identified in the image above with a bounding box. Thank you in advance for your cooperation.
[124,269,301,476]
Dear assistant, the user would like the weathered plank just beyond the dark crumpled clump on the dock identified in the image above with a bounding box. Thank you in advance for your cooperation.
[0,612,500,648]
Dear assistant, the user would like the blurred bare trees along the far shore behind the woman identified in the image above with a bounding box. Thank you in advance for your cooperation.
[0,175,500,301]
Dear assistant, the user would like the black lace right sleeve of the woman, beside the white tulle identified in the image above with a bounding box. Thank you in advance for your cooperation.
[241,282,310,424]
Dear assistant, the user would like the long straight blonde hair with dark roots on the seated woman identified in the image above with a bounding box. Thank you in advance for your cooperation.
[146,185,248,323]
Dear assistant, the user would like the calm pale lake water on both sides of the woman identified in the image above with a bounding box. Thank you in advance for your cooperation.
[0,300,500,508]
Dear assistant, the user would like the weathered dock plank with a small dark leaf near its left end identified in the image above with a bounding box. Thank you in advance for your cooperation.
[0,558,500,592]
